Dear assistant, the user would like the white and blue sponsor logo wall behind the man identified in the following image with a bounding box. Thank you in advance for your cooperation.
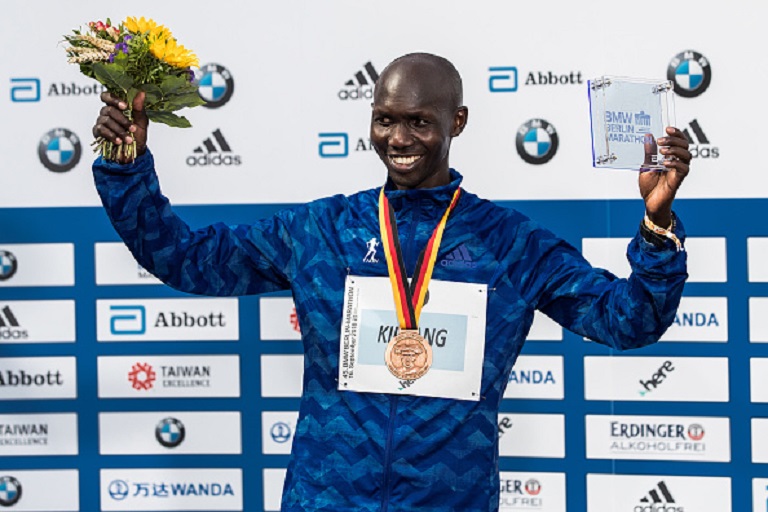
[0,0,768,512]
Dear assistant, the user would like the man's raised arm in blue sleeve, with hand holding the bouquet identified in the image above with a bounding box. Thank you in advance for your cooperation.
[93,93,294,295]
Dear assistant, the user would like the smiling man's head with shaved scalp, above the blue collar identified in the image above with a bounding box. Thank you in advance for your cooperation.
[371,62,466,189]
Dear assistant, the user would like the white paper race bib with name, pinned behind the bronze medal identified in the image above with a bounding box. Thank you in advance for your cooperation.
[339,276,488,400]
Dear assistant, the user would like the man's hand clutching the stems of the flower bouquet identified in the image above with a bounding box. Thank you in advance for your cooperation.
[93,92,149,162]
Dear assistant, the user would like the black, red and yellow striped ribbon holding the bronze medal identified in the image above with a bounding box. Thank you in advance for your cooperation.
[379,187,461,329]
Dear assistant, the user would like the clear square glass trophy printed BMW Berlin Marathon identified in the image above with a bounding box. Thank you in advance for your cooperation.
[587,76,675,171]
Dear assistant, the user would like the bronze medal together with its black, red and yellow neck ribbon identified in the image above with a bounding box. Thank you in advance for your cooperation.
[379,187,461,380]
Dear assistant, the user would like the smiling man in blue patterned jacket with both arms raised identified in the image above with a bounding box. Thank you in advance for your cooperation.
[93,54,691,512]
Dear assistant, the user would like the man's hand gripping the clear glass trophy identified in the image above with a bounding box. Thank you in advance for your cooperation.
[638,126,692,228]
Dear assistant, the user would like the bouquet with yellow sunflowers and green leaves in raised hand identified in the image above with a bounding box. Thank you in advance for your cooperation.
[64,16,205,161]
